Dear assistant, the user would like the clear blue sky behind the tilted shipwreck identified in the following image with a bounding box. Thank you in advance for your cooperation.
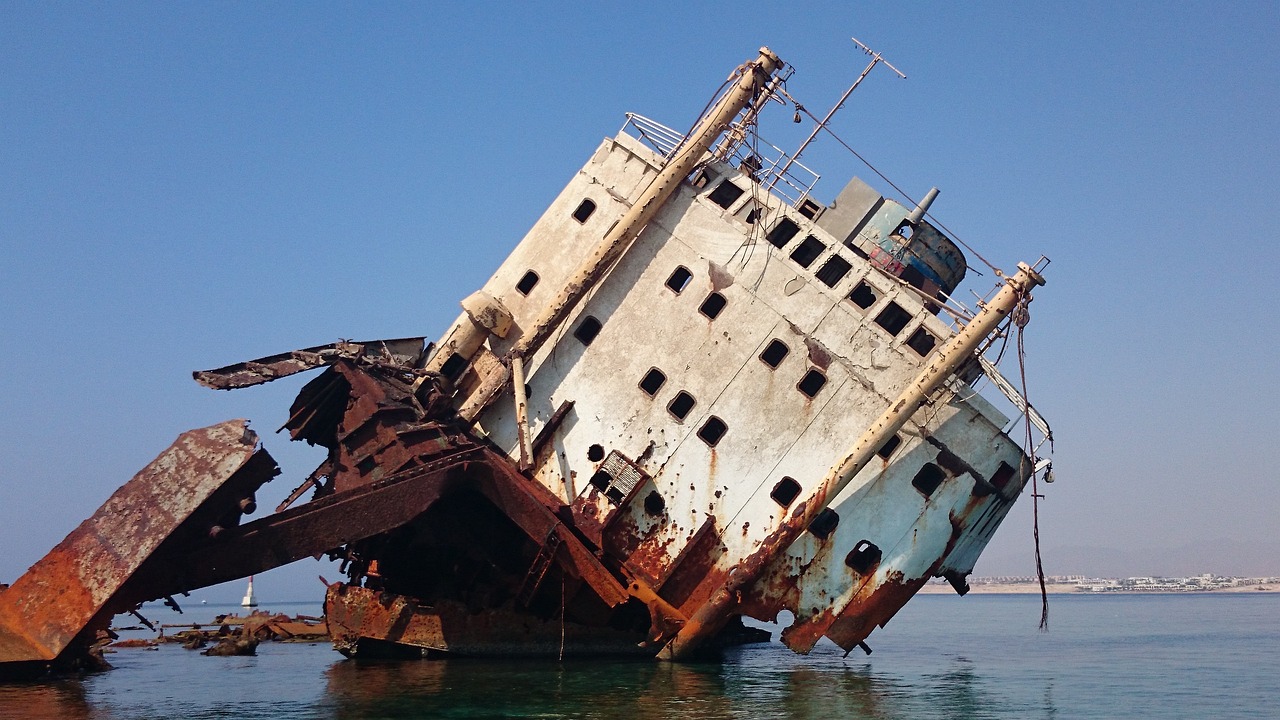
[0,1,1280,598]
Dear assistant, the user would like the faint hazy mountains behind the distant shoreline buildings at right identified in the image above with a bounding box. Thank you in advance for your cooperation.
[973,537,1280,578]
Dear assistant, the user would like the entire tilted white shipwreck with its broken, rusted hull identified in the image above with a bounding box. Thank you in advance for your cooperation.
[0,49,1047,675]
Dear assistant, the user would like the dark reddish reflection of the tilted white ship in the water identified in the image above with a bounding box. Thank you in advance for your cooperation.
[317,646,1056,720]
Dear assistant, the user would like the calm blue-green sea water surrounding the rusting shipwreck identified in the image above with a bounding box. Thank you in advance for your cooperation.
[0,593,1280,720]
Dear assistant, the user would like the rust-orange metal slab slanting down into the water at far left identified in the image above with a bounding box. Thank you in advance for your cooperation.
[0,420,275,664]
